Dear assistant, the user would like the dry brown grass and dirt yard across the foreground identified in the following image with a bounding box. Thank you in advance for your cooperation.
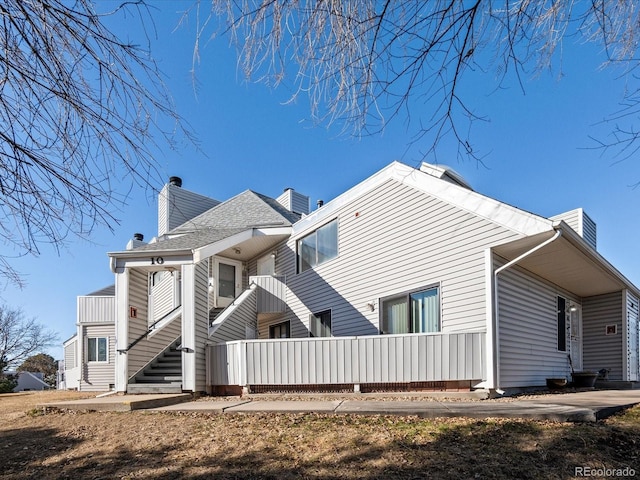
[0,391,640,480]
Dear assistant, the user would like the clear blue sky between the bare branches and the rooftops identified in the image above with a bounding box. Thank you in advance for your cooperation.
[0,2,640,358]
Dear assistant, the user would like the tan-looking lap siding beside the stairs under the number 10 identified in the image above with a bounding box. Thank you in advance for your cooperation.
[127,269,181,378]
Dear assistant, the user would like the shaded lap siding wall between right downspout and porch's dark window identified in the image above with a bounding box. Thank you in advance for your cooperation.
[498,267,575,388]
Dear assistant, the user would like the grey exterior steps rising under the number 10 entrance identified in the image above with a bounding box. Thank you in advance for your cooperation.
[127,338,182,394]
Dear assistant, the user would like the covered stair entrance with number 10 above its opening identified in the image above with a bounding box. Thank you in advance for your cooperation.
[110,228,288,393]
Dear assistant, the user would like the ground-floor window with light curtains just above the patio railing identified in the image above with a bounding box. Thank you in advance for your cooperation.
[380,287,440,334]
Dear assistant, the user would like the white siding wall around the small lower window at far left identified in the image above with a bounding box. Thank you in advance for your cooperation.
[80,325,116,392]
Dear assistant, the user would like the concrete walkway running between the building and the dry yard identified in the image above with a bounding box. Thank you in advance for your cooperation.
[41,390,640,422]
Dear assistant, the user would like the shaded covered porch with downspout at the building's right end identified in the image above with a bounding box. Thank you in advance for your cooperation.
[487,222,639,389]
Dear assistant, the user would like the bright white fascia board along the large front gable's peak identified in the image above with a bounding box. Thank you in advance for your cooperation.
[293,161,553,235]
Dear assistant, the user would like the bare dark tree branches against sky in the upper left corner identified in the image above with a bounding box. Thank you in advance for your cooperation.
[0,0,186,283]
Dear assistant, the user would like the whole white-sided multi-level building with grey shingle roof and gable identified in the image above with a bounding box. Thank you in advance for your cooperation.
[65,162,640,392]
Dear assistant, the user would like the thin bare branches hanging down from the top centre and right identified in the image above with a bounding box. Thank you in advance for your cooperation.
[194,0,640,159]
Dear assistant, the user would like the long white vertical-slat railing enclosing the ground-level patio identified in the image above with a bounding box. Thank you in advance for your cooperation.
[207,332,486,386]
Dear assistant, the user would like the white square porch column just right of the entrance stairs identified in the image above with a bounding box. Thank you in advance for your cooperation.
[182,264,196,392]
